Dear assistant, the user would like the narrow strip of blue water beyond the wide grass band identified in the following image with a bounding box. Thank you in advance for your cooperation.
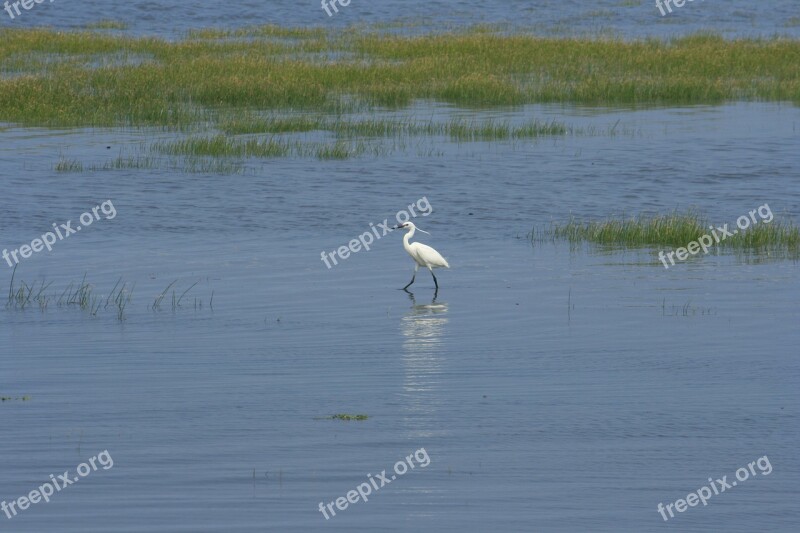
[0,0,800,38]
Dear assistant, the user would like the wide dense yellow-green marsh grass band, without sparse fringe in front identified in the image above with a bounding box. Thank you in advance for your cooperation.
[0,26,800,128]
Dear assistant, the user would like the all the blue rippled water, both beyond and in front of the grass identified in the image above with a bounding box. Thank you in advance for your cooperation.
[0,0,800,533]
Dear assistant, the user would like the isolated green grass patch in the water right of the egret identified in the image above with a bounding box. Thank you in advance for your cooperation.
[529,211,800,257]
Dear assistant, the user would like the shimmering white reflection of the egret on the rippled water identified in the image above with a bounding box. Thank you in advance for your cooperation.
[400,291,449,437]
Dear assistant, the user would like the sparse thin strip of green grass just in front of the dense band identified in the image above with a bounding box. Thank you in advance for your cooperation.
[56,113,620,170]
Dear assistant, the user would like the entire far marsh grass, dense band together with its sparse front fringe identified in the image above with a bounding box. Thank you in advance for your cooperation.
[0,21,800,170]
